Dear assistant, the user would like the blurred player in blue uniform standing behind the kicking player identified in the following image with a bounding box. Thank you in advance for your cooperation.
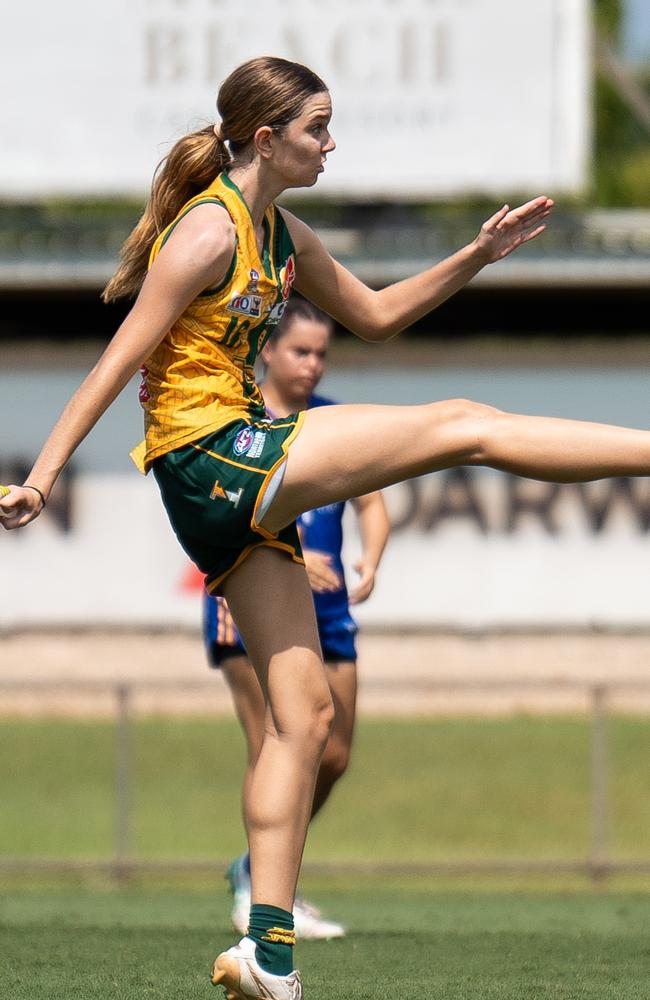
[204,297,390,940]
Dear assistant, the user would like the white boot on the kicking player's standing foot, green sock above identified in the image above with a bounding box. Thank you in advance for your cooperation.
[212,937,302,1000]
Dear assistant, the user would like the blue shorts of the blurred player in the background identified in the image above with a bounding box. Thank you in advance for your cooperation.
[203,597,358,667]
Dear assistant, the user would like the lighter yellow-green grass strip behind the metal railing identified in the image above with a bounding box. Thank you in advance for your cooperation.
[0,716,650,863]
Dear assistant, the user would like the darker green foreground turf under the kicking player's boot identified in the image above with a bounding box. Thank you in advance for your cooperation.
[0,882,650,1000]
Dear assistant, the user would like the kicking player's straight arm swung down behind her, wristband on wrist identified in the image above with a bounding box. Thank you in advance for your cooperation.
[0,204,235,528]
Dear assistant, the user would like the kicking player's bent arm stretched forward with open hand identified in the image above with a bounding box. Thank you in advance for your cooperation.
[282,196,553,341]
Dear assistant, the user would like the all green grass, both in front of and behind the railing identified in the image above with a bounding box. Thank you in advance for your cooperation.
[0,717,650,1000]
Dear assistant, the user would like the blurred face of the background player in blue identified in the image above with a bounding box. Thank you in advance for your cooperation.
[262,316,330,409]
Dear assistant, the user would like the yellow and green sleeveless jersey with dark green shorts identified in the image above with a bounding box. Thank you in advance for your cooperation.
[132,173,304,592]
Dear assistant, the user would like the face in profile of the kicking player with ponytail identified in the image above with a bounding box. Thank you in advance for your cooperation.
[274,91,336,187]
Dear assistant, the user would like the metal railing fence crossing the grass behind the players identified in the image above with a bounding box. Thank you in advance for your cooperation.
[0,675,650,882]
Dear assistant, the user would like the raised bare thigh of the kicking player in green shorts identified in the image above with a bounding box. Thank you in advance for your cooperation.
[263,400,498,531]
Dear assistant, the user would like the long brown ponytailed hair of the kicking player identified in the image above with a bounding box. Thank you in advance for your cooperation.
[107,56,327,302]
